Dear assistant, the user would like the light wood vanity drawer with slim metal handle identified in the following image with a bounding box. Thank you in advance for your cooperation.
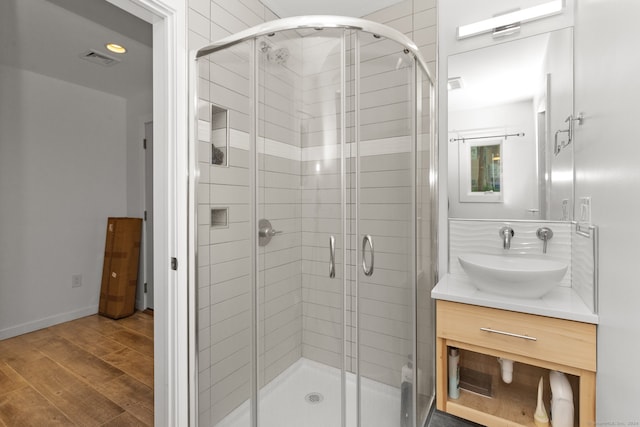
[436,300,596,372]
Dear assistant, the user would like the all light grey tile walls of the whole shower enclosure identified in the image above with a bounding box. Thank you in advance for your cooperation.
[189,0,435,425]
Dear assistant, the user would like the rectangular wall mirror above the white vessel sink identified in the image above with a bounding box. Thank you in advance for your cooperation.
[448,28,574,220]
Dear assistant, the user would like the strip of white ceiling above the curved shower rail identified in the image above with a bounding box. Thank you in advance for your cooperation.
[262,0,402,18]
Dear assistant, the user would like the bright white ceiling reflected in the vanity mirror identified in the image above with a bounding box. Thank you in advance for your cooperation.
[448,34,549,111]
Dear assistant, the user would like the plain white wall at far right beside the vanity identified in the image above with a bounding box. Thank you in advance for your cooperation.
[575,0,640,425]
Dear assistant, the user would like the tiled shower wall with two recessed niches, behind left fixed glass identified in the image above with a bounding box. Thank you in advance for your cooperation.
[195,25,255,426]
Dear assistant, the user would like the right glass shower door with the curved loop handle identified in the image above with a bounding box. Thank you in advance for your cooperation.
[353,34,416,427]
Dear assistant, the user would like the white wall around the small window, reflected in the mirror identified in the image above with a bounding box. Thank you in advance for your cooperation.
[447,100,538,219]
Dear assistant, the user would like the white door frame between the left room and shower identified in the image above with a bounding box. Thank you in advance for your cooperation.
[107,0,189,427]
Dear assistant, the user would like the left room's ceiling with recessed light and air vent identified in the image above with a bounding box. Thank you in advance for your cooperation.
[0,0,153,98]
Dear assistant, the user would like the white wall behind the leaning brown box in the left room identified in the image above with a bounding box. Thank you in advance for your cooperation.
[0,66,127,339]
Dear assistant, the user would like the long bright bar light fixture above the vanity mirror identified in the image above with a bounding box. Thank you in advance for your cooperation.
[458,0,563,39]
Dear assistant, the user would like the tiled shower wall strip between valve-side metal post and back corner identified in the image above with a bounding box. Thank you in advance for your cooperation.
[258,33,302,387]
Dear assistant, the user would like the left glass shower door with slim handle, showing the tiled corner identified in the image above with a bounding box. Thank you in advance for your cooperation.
[256,29,345,427]
